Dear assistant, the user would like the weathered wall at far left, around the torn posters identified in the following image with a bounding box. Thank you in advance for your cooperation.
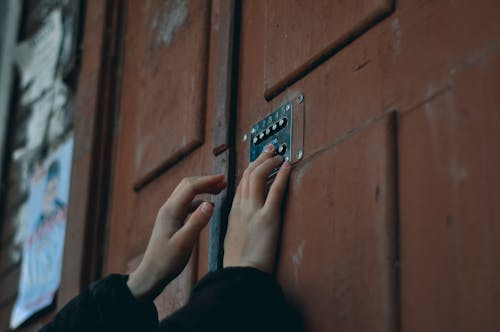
[0,0,79,331]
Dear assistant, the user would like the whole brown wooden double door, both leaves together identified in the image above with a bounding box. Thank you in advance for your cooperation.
[100,0,500,331]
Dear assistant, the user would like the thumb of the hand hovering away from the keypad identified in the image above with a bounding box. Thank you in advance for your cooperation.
[174,202,214,246]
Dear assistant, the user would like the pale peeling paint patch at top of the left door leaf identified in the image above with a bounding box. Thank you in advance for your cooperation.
[151,0,188,46]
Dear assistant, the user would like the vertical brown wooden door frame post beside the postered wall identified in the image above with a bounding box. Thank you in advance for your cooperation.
[58,0,123,308]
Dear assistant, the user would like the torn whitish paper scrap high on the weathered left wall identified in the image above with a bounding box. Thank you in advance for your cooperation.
[14,9,63,105]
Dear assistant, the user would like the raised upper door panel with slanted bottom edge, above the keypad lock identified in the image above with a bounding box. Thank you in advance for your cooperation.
[263,0,394,96]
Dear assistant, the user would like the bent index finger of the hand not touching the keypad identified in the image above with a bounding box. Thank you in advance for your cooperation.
[165,174,227,220]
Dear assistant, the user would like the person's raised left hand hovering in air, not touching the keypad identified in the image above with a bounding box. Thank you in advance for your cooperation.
[127,175,227,300]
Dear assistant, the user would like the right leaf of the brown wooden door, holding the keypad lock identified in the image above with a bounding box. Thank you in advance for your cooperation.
[236,0,500,331]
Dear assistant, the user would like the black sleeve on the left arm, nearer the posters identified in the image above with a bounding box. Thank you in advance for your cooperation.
[41,274,158,332]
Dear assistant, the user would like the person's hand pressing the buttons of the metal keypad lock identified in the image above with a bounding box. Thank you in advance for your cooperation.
[224,145,291,273]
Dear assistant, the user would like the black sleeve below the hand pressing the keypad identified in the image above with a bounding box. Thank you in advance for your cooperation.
[154,267,299,332]
